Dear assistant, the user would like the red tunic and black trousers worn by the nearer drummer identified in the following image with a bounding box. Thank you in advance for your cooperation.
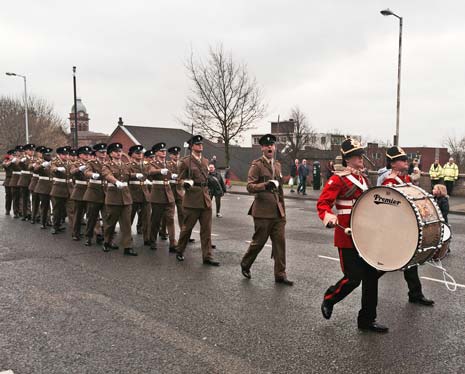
[317,168,383,327]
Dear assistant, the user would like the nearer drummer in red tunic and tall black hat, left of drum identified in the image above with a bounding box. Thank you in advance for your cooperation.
[317,138,388,333]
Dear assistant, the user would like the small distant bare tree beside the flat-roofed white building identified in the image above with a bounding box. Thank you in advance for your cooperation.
[285,106,316,160]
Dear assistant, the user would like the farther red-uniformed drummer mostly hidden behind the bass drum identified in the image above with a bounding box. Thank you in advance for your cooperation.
[378,145,434,306]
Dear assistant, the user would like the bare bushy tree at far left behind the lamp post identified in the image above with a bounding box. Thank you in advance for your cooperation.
[0,96,68,152]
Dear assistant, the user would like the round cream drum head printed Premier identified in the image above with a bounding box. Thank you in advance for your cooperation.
[351,186,419,271]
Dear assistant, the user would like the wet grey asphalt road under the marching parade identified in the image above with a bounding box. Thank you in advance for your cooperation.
[0,189,465,374]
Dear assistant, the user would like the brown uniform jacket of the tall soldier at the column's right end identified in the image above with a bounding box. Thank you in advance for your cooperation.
[178,155,212,209]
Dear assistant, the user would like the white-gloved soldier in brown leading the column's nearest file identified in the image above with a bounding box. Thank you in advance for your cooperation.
[102,143,137,256]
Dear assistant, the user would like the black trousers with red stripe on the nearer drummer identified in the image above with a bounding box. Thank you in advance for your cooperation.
[324,248,384,324]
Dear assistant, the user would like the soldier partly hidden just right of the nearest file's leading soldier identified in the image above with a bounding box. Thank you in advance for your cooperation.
[128,144,150,245]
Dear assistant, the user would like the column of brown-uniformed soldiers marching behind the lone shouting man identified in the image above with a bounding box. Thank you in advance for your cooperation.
[2,136,219,266]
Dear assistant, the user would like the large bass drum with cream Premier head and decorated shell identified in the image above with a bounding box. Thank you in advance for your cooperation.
[350,184,444,271]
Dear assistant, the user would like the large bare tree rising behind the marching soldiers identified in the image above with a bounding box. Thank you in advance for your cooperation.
[185,45,266,166]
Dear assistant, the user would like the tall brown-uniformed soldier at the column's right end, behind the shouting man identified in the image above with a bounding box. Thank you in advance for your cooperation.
[176,135,220,266]
